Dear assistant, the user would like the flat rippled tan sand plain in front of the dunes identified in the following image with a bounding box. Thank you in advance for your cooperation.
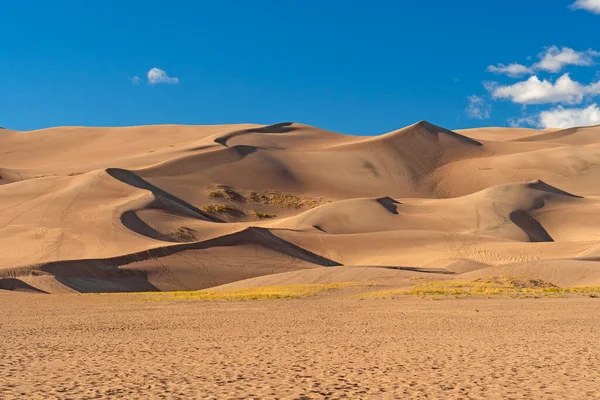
[0,293,600,400]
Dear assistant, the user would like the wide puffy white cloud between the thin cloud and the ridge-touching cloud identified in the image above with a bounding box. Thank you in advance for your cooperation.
[484,74,600,104]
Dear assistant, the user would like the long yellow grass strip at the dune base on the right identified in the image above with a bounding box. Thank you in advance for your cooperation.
[360,277,600,298]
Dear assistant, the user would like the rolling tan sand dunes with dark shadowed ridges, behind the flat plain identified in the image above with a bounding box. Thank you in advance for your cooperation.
[0,121,600,293]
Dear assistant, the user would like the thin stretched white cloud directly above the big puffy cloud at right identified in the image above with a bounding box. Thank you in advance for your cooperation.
[487,46,600,78]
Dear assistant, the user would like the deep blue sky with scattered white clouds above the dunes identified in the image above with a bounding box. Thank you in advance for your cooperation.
[0,0,600,135]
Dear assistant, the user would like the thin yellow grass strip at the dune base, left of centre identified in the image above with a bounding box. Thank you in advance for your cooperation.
[148,282,357,301]
